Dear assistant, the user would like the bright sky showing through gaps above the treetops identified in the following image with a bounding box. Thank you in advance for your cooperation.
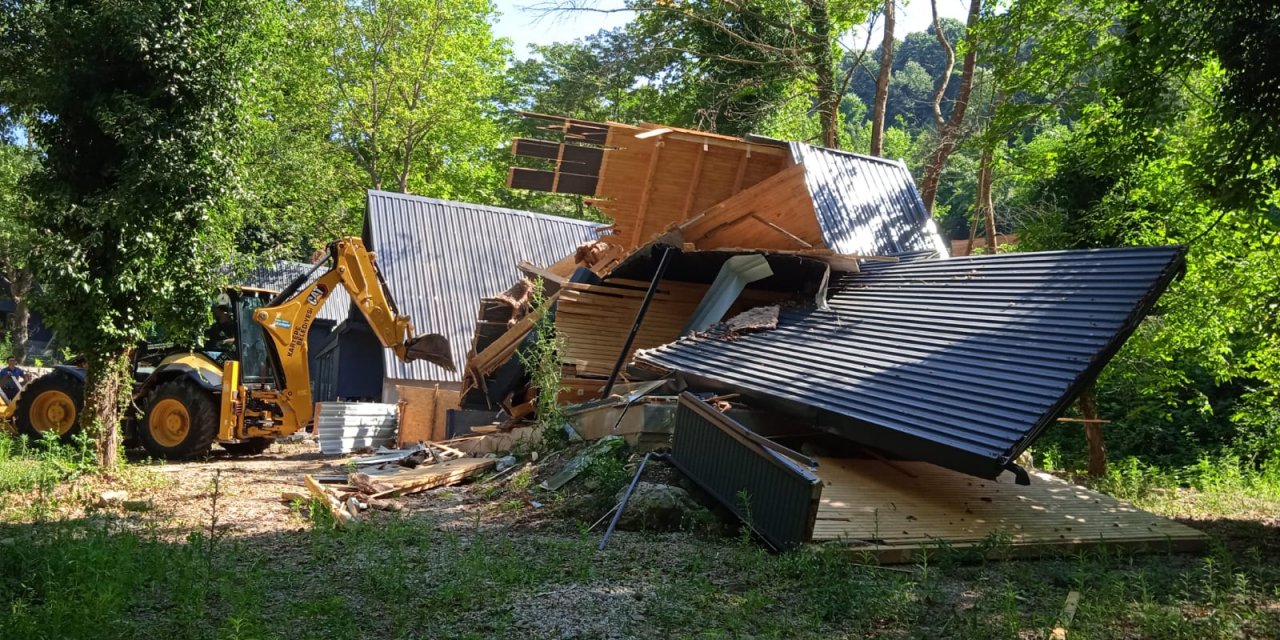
[494,0,969,58]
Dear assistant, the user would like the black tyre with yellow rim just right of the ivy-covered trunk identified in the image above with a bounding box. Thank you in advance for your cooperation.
[137,378,218,460]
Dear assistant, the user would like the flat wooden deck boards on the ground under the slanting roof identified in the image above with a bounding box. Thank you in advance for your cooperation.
[813,458,1206,562]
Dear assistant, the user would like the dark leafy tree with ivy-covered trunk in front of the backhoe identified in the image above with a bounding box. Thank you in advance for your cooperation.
[0,0,252,468]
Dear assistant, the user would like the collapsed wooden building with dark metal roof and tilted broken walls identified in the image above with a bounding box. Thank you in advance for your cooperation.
[381,114,1203,559]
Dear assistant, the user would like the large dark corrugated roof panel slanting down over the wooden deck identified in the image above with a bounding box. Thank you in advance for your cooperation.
[636,247,1184,477]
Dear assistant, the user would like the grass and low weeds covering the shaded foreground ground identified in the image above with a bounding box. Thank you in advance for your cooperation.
[0,437,1280,640]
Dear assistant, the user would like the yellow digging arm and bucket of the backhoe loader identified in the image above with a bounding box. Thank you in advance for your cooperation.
[245,238,454,433]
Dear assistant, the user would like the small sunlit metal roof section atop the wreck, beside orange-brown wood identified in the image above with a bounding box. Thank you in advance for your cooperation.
[791,142,947,256]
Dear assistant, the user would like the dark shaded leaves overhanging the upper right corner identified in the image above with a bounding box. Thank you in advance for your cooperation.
[1108,0,1280,216]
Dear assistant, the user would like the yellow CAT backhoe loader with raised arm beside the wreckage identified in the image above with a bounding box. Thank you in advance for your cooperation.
[0,238,453,460]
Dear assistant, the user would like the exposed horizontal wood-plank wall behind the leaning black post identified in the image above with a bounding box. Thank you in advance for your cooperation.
[556,280,707,376]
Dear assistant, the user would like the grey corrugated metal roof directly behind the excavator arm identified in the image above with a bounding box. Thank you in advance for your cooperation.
[365,191,603,381]
